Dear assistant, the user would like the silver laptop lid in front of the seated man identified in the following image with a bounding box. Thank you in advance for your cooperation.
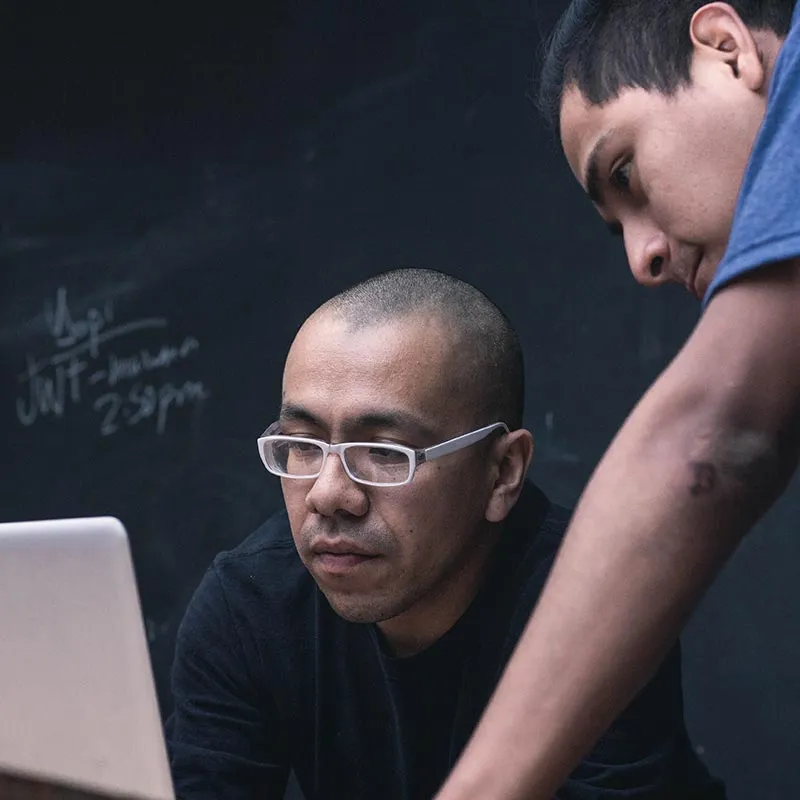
[0,517,174,800]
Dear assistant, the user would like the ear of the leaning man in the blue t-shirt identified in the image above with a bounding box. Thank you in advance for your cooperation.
[689,3,767,92]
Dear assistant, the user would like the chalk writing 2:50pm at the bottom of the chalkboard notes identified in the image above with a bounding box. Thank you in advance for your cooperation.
[93,381,208,436]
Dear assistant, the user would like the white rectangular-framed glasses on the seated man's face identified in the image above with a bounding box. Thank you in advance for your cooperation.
[258,422,509,486]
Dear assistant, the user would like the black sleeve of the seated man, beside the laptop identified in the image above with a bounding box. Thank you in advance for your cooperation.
[166,567,289,800]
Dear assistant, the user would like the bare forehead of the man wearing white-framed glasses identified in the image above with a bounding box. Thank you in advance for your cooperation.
[283,314,463,425]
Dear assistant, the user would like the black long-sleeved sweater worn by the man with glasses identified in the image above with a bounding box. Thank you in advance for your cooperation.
[167,486,724,800]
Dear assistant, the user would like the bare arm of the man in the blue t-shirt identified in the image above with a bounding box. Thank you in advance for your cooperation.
[437,260,800,800]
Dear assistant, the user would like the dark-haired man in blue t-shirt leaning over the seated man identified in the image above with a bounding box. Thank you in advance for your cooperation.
[438,0,800,800]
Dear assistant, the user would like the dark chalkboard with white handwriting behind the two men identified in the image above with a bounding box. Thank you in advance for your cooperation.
[0,0,800,800]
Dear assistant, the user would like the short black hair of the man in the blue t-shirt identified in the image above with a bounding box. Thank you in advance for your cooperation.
[537,0,795,130]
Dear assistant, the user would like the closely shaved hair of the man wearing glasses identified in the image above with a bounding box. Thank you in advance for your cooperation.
[320,269,525,430]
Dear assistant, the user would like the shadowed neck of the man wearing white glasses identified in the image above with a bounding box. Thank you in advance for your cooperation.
[378,525,501,658]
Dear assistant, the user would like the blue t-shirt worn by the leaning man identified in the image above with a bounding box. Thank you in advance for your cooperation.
[703,4,800,306]
